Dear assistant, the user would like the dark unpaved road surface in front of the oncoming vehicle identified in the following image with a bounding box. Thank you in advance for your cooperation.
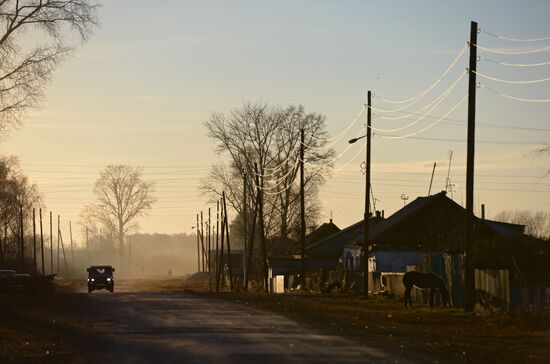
[46,291,410,364]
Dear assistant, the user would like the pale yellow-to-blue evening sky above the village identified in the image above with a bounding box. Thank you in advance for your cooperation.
[0,0,550,246]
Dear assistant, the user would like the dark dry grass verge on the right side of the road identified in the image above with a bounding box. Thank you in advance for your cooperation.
[187,274,550,363]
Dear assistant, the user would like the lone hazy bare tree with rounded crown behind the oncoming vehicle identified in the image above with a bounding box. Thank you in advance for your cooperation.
[80,165,155,264]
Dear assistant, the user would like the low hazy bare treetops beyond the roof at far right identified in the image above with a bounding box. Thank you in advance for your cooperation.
[495,210,550,239]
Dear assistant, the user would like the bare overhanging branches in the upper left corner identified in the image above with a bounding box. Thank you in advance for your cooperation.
[0,0,98,135]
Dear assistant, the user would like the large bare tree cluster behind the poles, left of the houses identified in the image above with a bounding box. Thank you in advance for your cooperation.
[201,103,334,243]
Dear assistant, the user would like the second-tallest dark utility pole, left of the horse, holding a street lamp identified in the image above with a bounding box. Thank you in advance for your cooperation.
[363,91,372,298]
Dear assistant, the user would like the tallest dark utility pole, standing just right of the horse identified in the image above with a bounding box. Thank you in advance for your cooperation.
[464,21,478,312]
